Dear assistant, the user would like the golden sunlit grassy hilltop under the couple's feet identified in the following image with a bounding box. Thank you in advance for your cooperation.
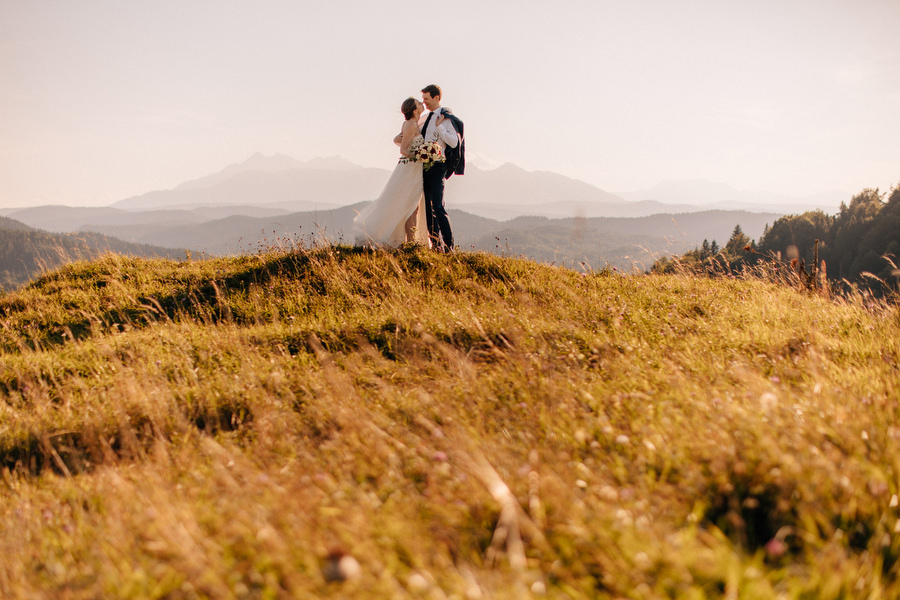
[0,247,900,599]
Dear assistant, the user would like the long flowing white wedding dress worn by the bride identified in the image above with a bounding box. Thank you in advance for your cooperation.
[353,135,429,247]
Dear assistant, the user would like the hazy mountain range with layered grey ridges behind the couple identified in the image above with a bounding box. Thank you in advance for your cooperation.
[0,154,845,276]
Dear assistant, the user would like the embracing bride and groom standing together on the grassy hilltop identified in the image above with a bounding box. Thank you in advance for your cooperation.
[353,85,465,252]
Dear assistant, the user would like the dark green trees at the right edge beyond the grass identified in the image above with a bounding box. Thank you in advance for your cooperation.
[652,186,900,295]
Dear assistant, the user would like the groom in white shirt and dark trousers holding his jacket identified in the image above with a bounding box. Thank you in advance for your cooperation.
[422,84,460,252]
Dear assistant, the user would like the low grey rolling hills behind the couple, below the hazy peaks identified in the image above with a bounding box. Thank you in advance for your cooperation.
[0,203,780,271]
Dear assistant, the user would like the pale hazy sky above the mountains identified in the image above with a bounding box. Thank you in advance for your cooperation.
[0,0,900,207]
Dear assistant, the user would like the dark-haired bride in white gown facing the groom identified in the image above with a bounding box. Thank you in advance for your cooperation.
[353,98,429,246]
